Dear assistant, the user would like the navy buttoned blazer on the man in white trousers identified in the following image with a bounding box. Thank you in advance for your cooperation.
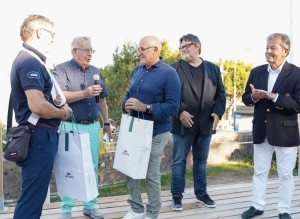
[242,62,300,147]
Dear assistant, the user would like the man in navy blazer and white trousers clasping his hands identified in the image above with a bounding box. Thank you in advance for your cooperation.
[242,33,300,219]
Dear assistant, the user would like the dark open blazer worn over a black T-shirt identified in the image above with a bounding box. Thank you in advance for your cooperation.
[171,59,226,135]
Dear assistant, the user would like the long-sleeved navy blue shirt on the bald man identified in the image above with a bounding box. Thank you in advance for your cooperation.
[122,59,181,135]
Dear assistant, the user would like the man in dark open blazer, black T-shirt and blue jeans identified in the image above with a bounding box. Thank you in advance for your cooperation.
[171,34,226,211]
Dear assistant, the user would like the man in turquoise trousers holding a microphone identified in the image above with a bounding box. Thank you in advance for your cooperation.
[53,36,111,219]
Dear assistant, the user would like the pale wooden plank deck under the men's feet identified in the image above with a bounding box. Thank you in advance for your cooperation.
[0,177,300,219]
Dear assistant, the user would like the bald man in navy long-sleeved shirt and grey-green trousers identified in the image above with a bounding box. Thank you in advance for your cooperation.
[122,36,180,219]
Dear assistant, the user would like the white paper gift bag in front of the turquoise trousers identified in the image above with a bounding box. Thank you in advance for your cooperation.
[54,131,98,201]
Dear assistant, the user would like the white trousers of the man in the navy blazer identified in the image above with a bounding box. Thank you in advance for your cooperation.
[251,140,297,214]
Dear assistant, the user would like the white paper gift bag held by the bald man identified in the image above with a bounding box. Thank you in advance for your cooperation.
[113,114,153,179]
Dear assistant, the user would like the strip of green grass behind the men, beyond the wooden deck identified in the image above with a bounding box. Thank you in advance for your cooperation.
[51,161,276,202]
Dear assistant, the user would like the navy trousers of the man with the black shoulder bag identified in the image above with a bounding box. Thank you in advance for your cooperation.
[14,125,58,219]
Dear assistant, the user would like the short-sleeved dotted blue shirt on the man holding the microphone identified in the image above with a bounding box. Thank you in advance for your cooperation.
[53,59,108,121]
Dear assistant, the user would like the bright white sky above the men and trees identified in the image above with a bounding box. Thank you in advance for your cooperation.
[0,0,300,121]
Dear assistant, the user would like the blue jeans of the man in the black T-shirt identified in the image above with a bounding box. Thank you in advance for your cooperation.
[171,134,211,198]
